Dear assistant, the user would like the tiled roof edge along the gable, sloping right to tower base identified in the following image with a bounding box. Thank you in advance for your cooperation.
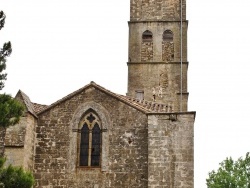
[38,81,172,114]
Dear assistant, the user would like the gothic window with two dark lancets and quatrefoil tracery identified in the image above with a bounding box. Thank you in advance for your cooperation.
[79,110,101,167]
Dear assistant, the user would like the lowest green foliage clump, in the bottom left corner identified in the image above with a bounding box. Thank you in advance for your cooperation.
[0,158,35,188]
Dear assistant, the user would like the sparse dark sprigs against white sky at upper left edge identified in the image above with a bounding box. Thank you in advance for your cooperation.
[0,11,12,90]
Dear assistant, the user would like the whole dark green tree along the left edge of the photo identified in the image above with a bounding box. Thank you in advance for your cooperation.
[0,11,32,188]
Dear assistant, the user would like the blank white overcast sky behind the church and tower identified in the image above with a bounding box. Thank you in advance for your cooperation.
[0,0,250,188]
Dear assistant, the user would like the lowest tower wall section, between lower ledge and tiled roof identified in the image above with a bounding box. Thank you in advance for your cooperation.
[128,63,188,111]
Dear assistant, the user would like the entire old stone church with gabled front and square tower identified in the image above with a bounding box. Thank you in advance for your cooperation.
[0,0,195,188]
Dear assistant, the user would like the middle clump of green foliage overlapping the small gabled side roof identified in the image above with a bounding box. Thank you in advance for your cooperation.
[0,94,24,128]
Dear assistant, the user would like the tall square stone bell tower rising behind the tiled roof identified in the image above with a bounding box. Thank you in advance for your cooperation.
[127,0,188,111]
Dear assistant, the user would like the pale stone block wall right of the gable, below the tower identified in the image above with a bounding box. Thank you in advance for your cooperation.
[148,112,195,188]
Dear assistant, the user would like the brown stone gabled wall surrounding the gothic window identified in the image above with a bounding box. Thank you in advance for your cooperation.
[34,88,148,188]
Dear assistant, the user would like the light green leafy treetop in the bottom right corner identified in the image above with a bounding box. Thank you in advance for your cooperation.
[206,152,250,188]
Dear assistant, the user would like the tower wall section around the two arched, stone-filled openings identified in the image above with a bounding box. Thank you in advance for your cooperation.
[129,22,188,62]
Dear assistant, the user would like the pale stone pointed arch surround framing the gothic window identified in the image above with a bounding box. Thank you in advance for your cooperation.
[69,101,111,171]
